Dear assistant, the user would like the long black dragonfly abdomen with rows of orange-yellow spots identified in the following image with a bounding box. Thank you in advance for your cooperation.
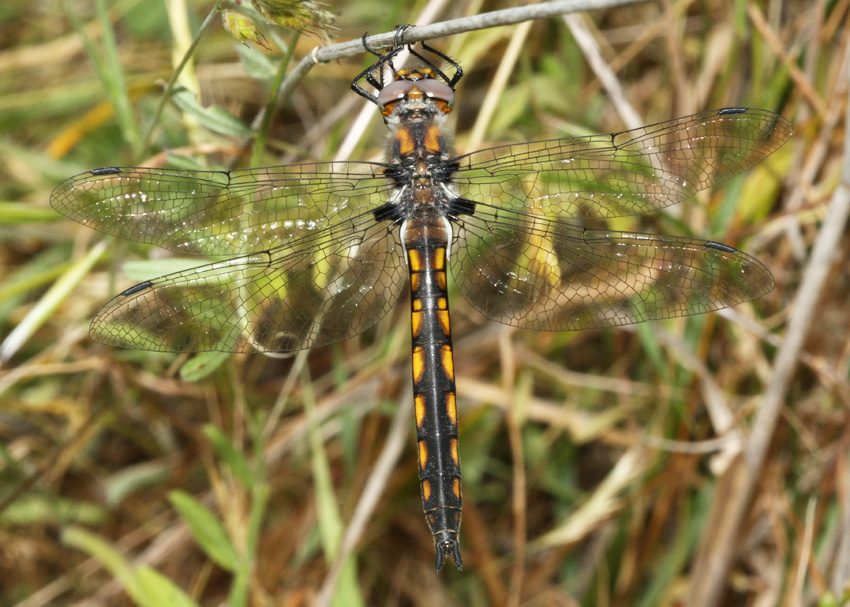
[402,214,462,571]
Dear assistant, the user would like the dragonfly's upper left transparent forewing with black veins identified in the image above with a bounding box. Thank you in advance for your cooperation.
[50,162,393,255]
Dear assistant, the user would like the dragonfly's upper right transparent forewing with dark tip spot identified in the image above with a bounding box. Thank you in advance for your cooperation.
[452,108,792,219]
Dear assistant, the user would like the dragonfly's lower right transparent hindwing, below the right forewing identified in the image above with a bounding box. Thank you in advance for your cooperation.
[452,210,773,331]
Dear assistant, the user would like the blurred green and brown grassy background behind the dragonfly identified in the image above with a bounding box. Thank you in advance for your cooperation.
[0,0,850,606]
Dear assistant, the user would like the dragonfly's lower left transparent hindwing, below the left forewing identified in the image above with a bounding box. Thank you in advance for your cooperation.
[91,216,406,352]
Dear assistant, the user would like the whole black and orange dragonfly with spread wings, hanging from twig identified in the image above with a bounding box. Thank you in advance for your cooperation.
[51,40,792,571]
